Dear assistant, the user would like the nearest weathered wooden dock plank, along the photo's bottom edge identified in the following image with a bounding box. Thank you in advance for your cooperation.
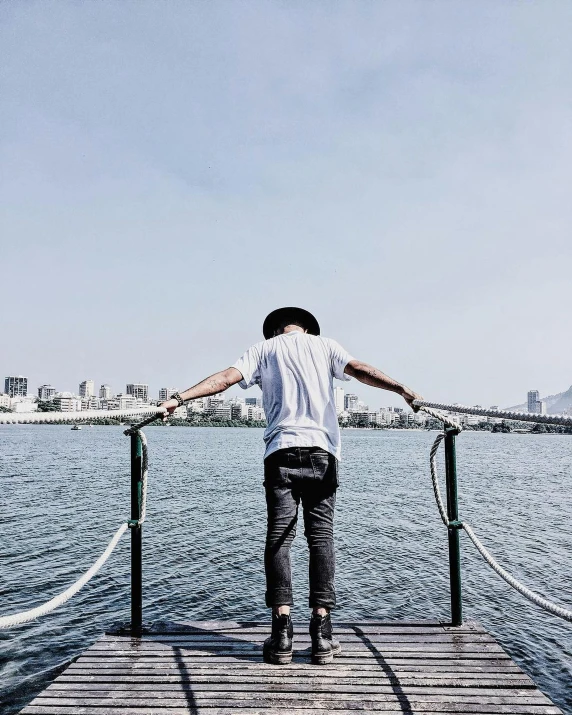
[24,694,558,715]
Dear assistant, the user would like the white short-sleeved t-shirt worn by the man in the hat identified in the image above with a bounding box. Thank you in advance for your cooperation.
[233,330,353,459]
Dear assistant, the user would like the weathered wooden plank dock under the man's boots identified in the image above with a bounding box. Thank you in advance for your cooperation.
[21,621,561,715]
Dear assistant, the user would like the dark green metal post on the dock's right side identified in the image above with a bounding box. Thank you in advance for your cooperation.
[445,427,463,626]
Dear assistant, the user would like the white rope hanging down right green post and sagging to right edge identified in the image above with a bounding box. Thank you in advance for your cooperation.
[429,415,572,621]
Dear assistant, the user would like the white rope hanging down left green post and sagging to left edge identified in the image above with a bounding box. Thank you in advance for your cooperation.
[0,428,150,629]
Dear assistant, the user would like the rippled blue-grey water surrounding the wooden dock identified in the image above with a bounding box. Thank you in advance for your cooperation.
[0,425,572,715]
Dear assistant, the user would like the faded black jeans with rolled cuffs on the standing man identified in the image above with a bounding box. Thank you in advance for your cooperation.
[264,447,338,608]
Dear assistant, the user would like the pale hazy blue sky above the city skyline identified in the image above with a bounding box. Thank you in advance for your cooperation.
[0,0,572,408]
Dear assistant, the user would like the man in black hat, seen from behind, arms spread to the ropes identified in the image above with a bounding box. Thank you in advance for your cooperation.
[161,307,420,664]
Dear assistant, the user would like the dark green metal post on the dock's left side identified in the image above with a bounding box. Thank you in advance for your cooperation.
[131,434,143,638]
